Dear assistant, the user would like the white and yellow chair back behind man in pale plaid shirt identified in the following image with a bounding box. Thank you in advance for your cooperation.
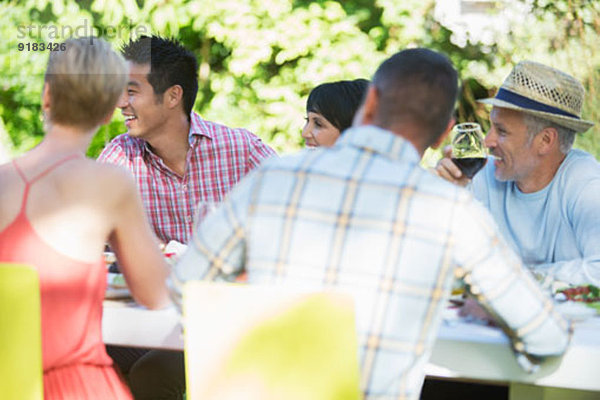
[183,282,361,400]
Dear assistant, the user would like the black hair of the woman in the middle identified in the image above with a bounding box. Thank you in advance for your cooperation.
[306,79,369,133]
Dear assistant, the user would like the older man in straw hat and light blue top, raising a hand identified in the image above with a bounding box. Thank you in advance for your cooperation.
[436,61,600,285]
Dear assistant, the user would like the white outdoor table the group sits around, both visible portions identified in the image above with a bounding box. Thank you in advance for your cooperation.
[102,300,600,400]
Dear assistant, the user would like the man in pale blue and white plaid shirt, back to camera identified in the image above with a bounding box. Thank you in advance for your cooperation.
[170,49,568,399]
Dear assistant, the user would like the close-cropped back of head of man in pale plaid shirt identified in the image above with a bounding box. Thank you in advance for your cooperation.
[373,48,458,146]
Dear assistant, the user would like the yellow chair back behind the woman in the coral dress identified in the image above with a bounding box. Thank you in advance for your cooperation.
[0,263,44,400]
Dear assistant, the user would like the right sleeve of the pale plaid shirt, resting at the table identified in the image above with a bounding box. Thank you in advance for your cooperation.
[453,197,569,356]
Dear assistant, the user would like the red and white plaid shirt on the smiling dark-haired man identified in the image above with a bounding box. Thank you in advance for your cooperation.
[98,113,275,243]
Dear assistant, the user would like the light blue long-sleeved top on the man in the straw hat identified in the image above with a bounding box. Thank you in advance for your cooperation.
[472,149,600,285]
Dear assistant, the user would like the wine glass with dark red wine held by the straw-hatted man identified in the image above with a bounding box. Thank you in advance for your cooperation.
[452,122,487,179]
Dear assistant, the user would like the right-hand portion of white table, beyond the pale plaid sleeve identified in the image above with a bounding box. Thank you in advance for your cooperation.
[426,317,600,400]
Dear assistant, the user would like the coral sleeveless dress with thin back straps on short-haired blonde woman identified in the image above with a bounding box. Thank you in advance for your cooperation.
[0,155,132,400]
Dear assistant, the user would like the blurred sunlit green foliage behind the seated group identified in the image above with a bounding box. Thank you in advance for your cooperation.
[0,0,600,158]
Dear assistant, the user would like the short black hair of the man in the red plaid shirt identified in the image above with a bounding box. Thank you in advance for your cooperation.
[121,36,198,119]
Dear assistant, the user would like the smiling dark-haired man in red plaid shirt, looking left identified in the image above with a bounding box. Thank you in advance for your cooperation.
[98,36,275,243]
